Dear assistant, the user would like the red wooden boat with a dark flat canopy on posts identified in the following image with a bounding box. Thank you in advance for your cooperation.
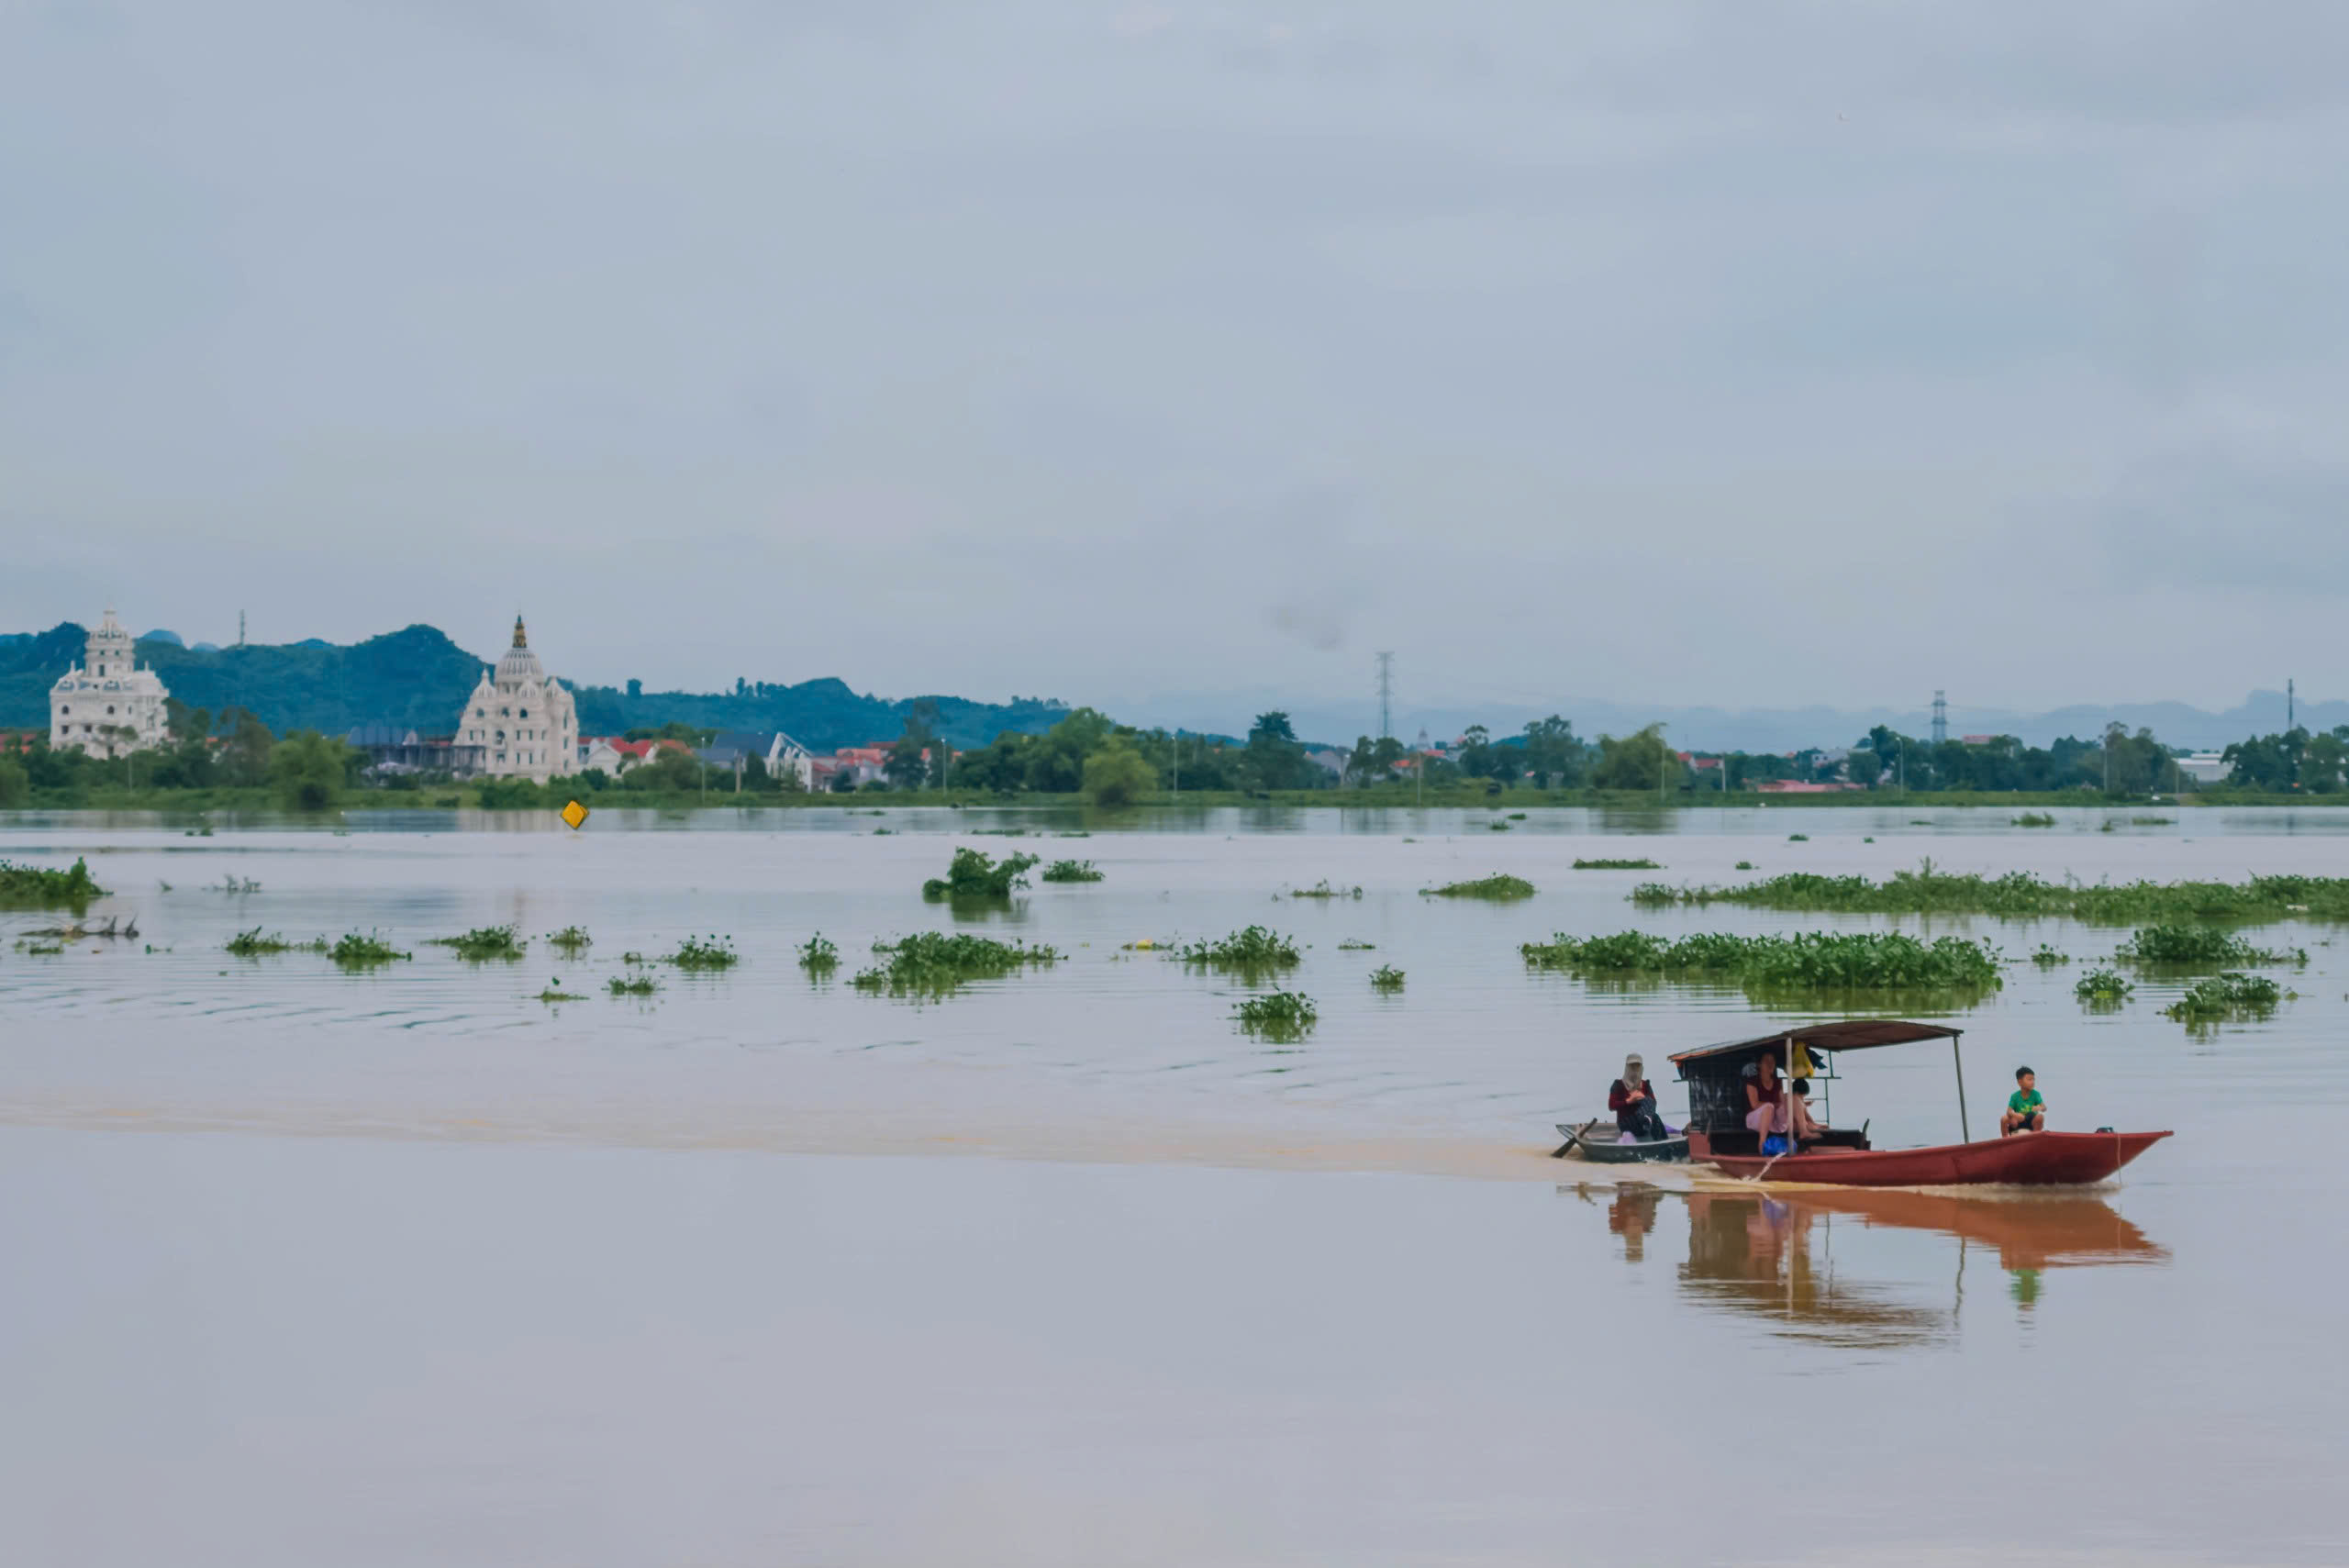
[1673,1018,2170,1188]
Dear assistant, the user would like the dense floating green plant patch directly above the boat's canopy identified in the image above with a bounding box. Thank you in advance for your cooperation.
[1518,932,2004,991]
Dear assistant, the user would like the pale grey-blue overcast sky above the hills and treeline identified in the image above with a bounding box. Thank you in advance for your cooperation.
[0,0,2349,723]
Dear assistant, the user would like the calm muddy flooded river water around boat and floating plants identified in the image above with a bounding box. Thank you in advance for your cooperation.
[0,807,2349,1563]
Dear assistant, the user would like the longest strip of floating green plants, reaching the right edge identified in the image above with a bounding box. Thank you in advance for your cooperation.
[1631,859,2349,925]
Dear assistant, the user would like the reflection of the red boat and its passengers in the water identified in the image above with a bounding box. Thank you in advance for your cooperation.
[1560,1181,2170,1350]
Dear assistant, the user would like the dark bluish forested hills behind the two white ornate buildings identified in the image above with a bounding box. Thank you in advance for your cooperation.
[0,622,1066,751]
